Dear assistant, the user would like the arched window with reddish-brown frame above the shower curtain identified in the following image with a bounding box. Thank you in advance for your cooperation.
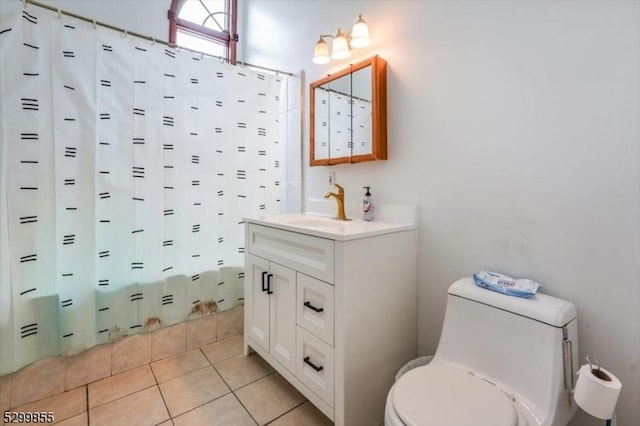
[169,0,238,63]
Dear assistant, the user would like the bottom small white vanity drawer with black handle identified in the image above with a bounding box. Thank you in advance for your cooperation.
[296,326,334,407]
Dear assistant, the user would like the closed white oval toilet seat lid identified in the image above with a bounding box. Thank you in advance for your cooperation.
[390,365,518,426]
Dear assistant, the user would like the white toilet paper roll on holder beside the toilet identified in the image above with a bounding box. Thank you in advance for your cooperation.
[573,364,622,420]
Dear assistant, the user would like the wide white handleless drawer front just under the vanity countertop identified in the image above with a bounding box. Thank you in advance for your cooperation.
[247,223,333,284]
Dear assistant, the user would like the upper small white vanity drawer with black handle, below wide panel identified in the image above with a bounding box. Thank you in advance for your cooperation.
[296,272,334,346]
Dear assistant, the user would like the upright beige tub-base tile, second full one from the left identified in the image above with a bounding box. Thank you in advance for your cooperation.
[65,343,111,390]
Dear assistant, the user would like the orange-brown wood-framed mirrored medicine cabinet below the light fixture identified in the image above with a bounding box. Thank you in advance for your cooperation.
[309,56,387,166]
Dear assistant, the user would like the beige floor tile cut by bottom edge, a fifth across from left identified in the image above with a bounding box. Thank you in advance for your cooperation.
[89,386,169,426]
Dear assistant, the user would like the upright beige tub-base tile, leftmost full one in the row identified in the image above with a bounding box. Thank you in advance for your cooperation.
[11,356,65,407]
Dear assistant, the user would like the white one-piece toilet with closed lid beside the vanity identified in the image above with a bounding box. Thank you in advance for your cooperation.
[385,278,579,426]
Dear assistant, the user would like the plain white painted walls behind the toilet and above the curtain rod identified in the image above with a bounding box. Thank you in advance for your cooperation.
[0,0,640,426]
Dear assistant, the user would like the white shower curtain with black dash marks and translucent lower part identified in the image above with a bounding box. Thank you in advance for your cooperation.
[0,8,300,374]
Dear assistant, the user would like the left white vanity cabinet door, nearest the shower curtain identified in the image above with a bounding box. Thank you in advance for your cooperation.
[244,254,270,351]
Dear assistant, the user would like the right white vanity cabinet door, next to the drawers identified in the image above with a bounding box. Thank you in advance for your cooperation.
[269,263,296,373]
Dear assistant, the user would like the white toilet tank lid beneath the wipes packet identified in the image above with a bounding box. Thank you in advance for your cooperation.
[449,278,576,327]
